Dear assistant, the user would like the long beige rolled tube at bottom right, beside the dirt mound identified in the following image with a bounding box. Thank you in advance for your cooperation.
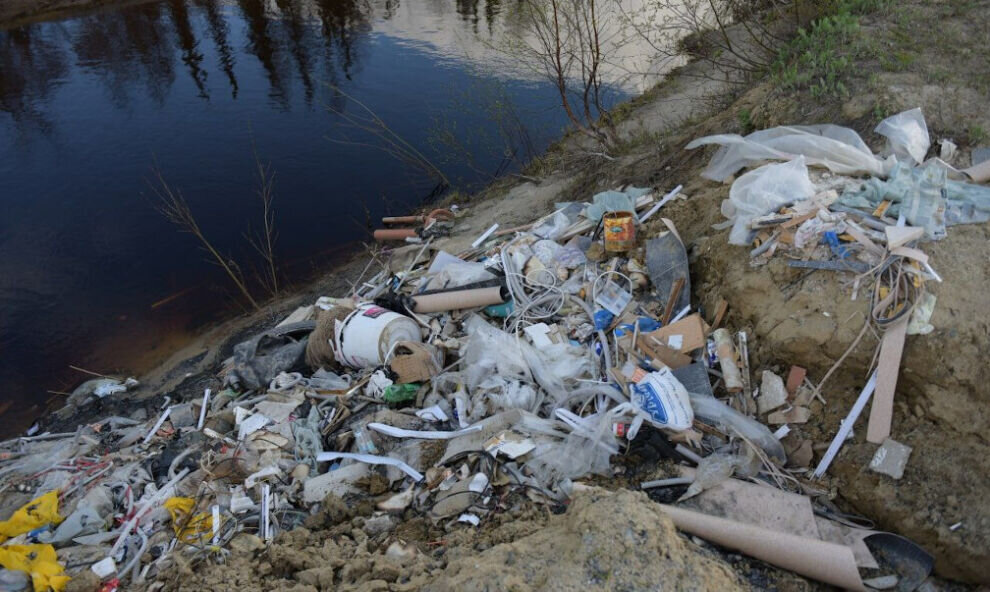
[660,504,866,591]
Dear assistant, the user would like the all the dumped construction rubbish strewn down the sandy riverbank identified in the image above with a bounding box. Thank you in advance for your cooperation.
[0,107,990,591]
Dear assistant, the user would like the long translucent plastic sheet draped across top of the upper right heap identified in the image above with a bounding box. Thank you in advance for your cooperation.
[687,109,931,182]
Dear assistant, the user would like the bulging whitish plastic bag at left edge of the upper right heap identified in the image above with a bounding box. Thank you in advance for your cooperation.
[722,156,815,245]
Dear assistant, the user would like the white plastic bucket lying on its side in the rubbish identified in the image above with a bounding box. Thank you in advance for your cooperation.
[333,304,423,368]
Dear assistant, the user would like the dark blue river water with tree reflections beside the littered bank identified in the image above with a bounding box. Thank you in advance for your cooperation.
[0,0,636,434]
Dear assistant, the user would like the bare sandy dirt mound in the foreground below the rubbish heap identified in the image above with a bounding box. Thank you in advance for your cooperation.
[155,490,750,592]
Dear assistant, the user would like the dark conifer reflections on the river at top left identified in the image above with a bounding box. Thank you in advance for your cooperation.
[0,0,374,125]
